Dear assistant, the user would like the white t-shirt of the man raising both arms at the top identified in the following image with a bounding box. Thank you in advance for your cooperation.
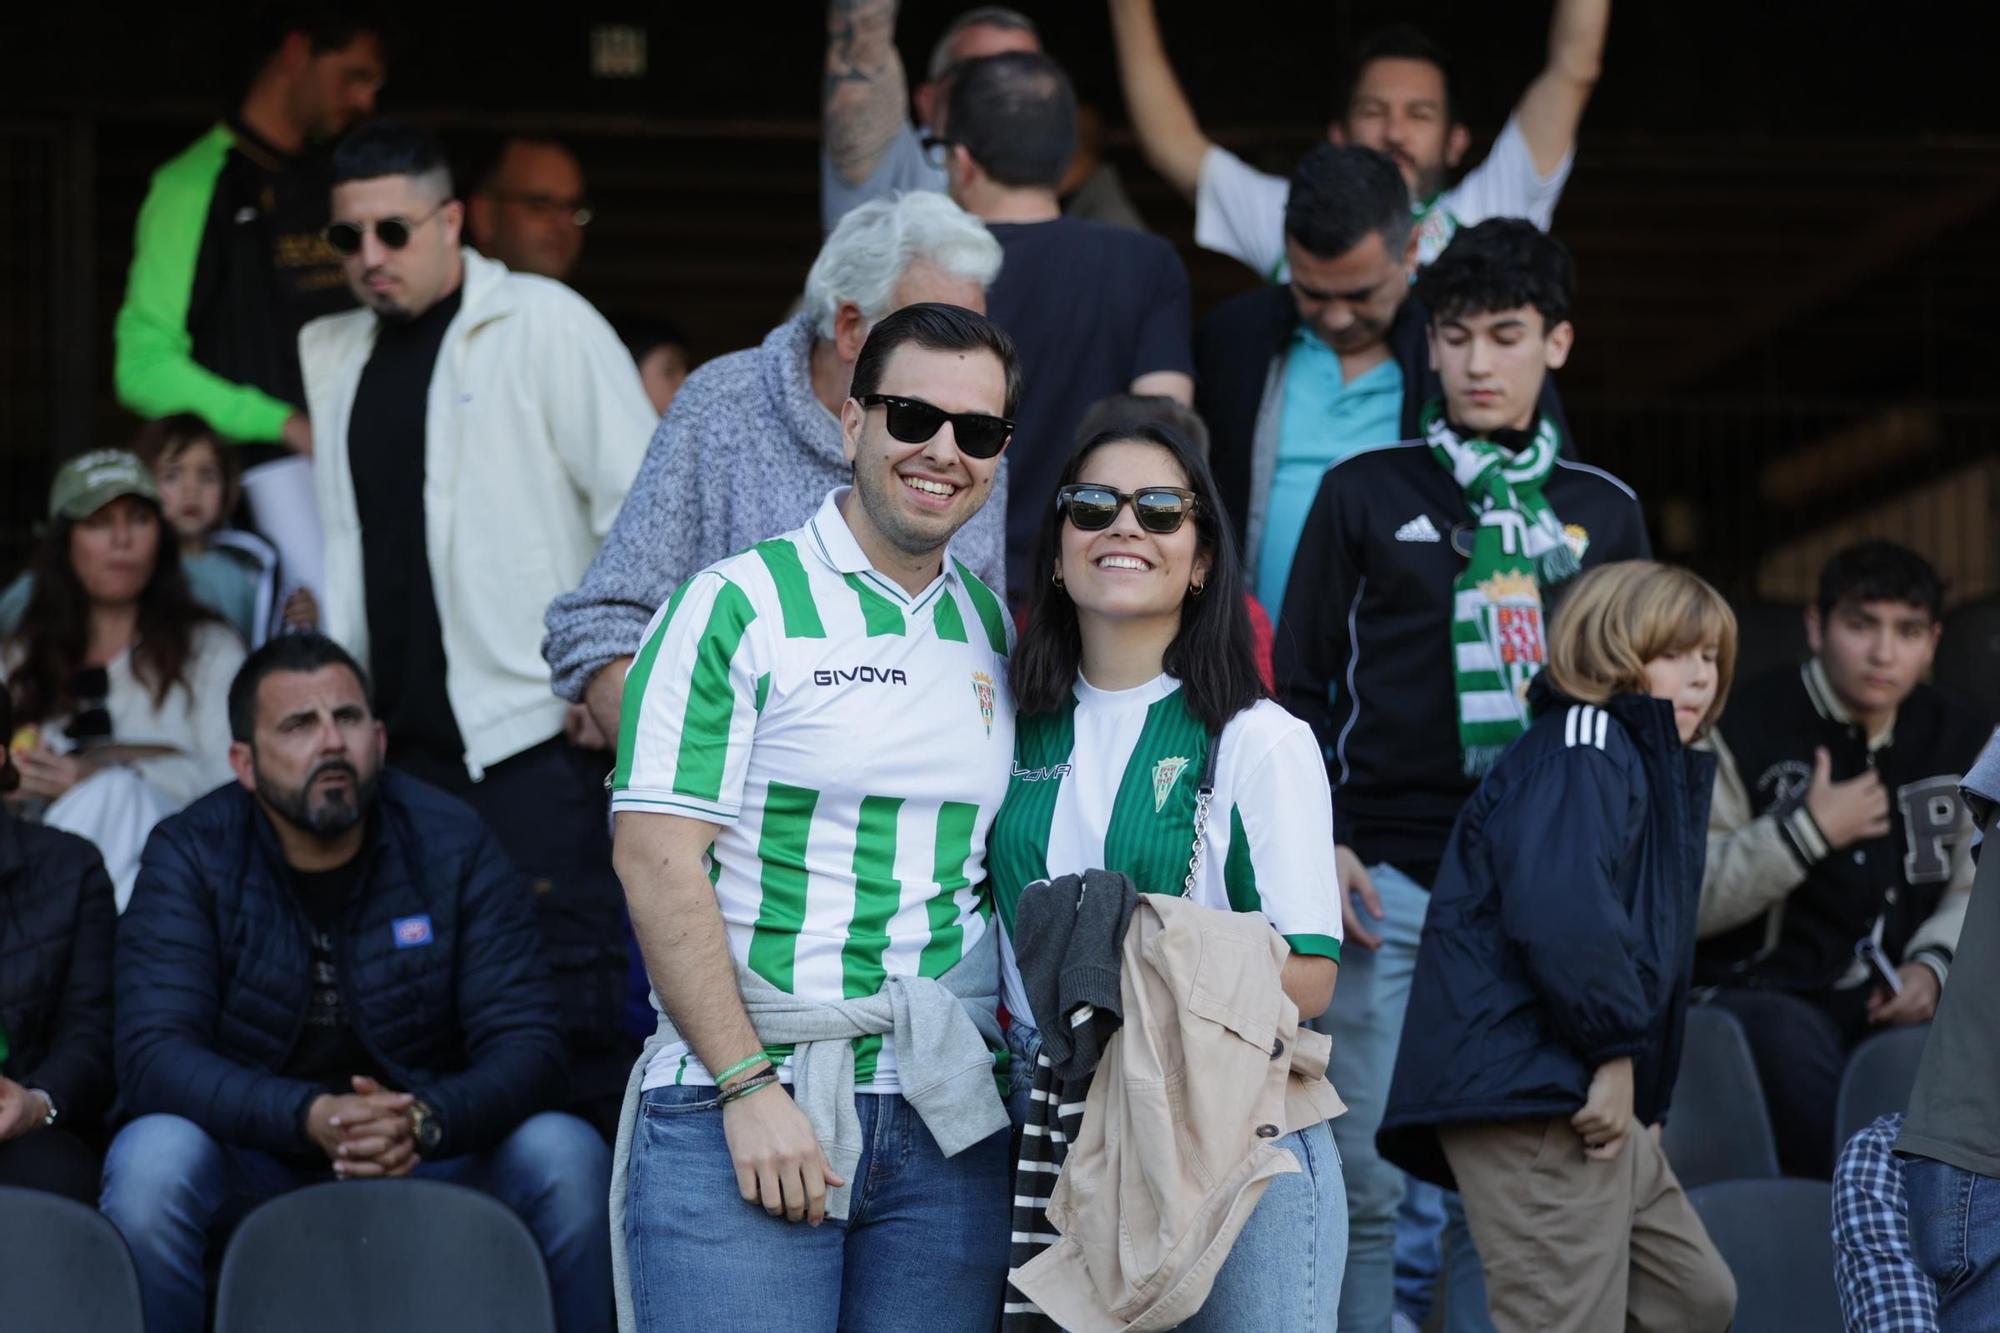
[1194,116,1576,282]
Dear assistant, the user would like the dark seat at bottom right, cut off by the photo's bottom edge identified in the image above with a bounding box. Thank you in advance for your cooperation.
[1688,1181,1842,1333]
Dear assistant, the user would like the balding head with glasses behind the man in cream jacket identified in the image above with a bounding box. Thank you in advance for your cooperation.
[466,136,590,282]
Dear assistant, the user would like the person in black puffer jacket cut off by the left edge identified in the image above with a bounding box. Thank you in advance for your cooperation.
[0,685,118,1203]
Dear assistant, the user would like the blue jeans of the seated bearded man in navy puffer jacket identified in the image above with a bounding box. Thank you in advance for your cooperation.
[98,1111,612,1333]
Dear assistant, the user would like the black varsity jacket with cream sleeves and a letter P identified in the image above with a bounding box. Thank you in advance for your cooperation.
[1696,660,1992,991]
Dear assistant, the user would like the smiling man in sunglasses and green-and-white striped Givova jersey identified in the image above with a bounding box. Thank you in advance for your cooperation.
[612,304,1020,1331]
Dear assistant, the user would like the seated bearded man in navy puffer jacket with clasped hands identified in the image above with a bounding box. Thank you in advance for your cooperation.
[102,634,610,1333]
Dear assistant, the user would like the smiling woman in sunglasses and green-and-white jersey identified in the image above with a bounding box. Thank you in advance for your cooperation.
[986,404,1348,1333]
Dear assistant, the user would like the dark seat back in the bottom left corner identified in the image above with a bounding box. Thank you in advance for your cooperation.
[0,1185,146,1333]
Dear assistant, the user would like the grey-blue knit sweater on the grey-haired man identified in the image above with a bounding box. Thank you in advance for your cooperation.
[542,314,1006,701]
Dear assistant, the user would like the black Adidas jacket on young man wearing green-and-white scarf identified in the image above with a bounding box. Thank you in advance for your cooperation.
[1274,440,1652,885]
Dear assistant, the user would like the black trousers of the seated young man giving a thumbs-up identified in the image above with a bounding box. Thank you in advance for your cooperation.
[1716,987,1874,1181]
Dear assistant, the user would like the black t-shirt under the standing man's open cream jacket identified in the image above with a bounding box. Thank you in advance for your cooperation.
[348,292,466,789]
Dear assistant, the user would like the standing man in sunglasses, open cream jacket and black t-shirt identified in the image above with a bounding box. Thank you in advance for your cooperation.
[300,122,654,1115]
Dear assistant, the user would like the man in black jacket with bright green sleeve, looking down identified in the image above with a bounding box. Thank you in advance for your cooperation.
[114,0,386,608]
